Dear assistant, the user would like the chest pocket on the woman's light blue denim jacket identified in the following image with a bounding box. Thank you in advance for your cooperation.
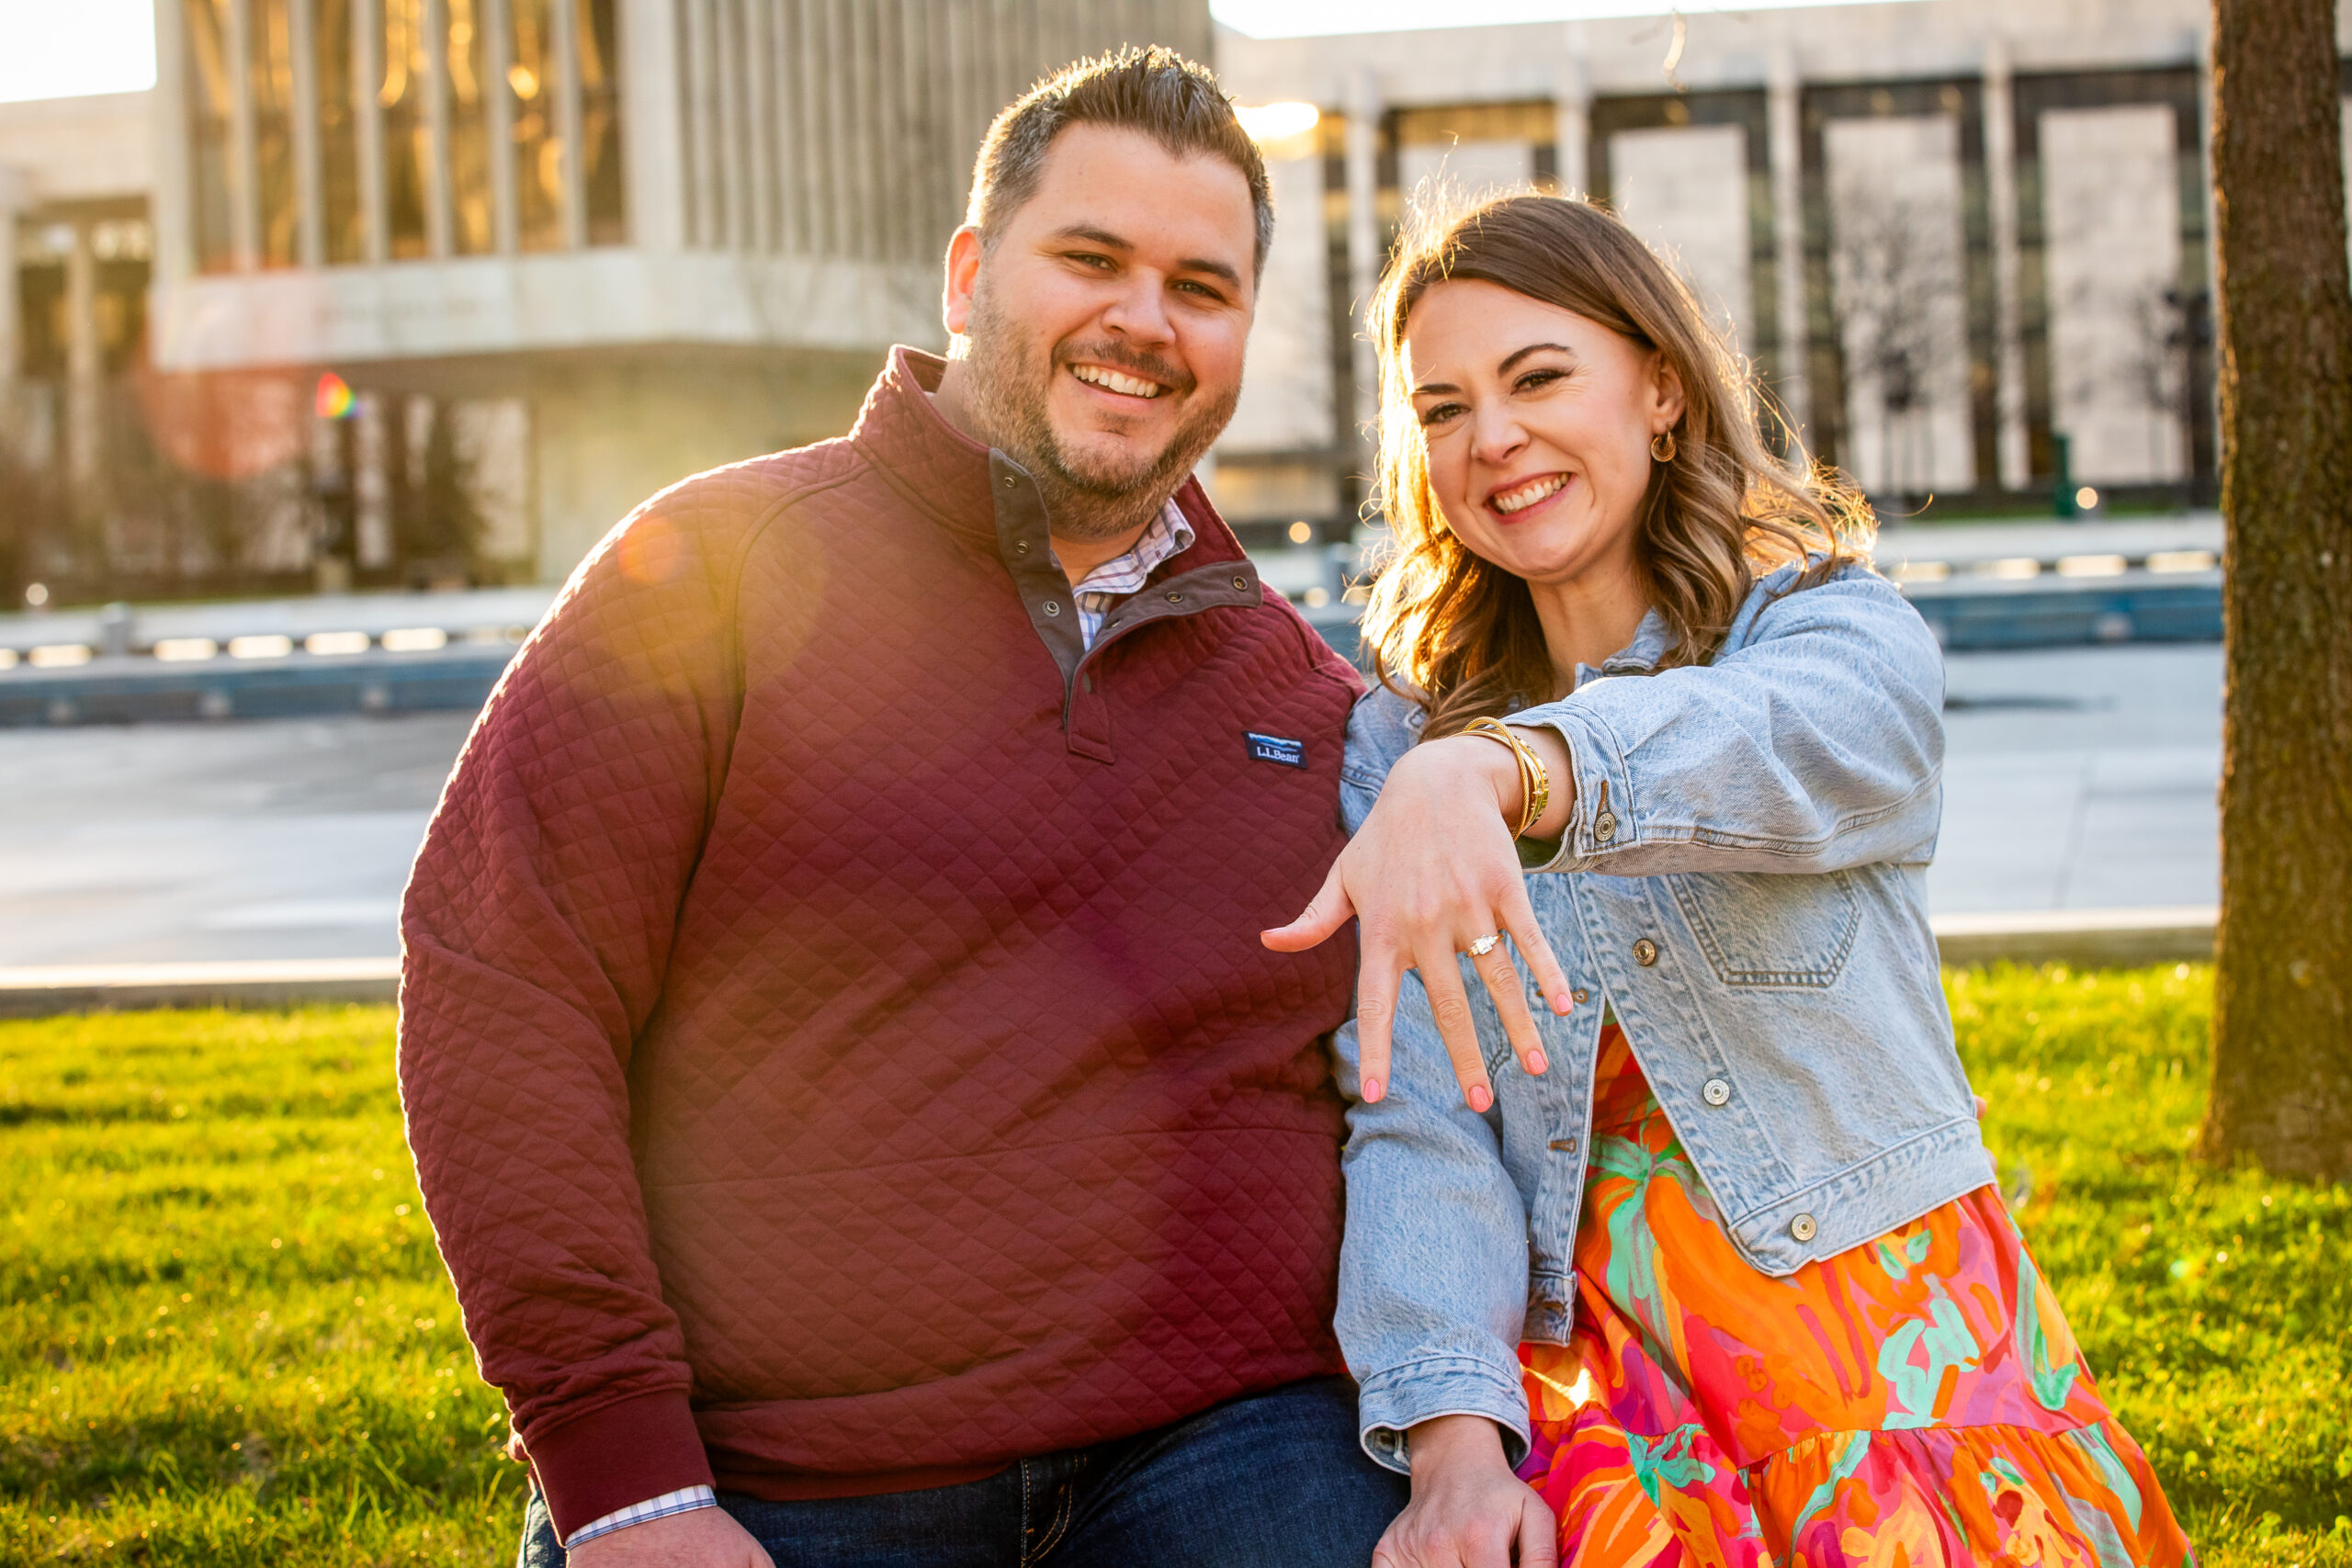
[1663,870,1863,989]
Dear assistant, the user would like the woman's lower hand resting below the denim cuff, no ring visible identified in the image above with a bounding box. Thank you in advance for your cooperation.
[1371,1416,1559,1568]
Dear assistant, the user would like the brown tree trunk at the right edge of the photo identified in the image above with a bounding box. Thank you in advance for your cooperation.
[2204,0,2352,1180]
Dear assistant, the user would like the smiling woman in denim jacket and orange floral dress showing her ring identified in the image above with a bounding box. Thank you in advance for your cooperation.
[1268,197,2189,1568]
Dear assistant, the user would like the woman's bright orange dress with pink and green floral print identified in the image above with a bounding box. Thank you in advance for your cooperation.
[1520,1022,2194,1568]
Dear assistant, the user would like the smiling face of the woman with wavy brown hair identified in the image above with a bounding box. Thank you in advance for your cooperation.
[1404,280,1681,583]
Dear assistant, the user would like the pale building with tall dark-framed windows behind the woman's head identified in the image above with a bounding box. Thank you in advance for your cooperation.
[1218,0,2352,545]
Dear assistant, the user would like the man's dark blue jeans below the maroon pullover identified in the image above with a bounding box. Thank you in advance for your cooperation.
[517,1378,1408,1568]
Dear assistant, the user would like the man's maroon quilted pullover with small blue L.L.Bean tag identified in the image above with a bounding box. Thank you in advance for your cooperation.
[400,350,1355,1533]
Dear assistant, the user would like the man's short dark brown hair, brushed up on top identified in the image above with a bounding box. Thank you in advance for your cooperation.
[965,45,1275,275]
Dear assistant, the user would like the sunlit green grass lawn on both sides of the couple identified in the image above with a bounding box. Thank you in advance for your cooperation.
[0,968,2352,1568]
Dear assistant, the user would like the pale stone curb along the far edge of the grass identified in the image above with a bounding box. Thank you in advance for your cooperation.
[0,905,2216,1018]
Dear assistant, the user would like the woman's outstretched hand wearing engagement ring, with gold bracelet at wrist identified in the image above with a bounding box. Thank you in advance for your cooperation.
[1261,728,1576,1112]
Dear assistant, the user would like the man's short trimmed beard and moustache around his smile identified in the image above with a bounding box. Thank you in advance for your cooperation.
[962,294,1239,541]
